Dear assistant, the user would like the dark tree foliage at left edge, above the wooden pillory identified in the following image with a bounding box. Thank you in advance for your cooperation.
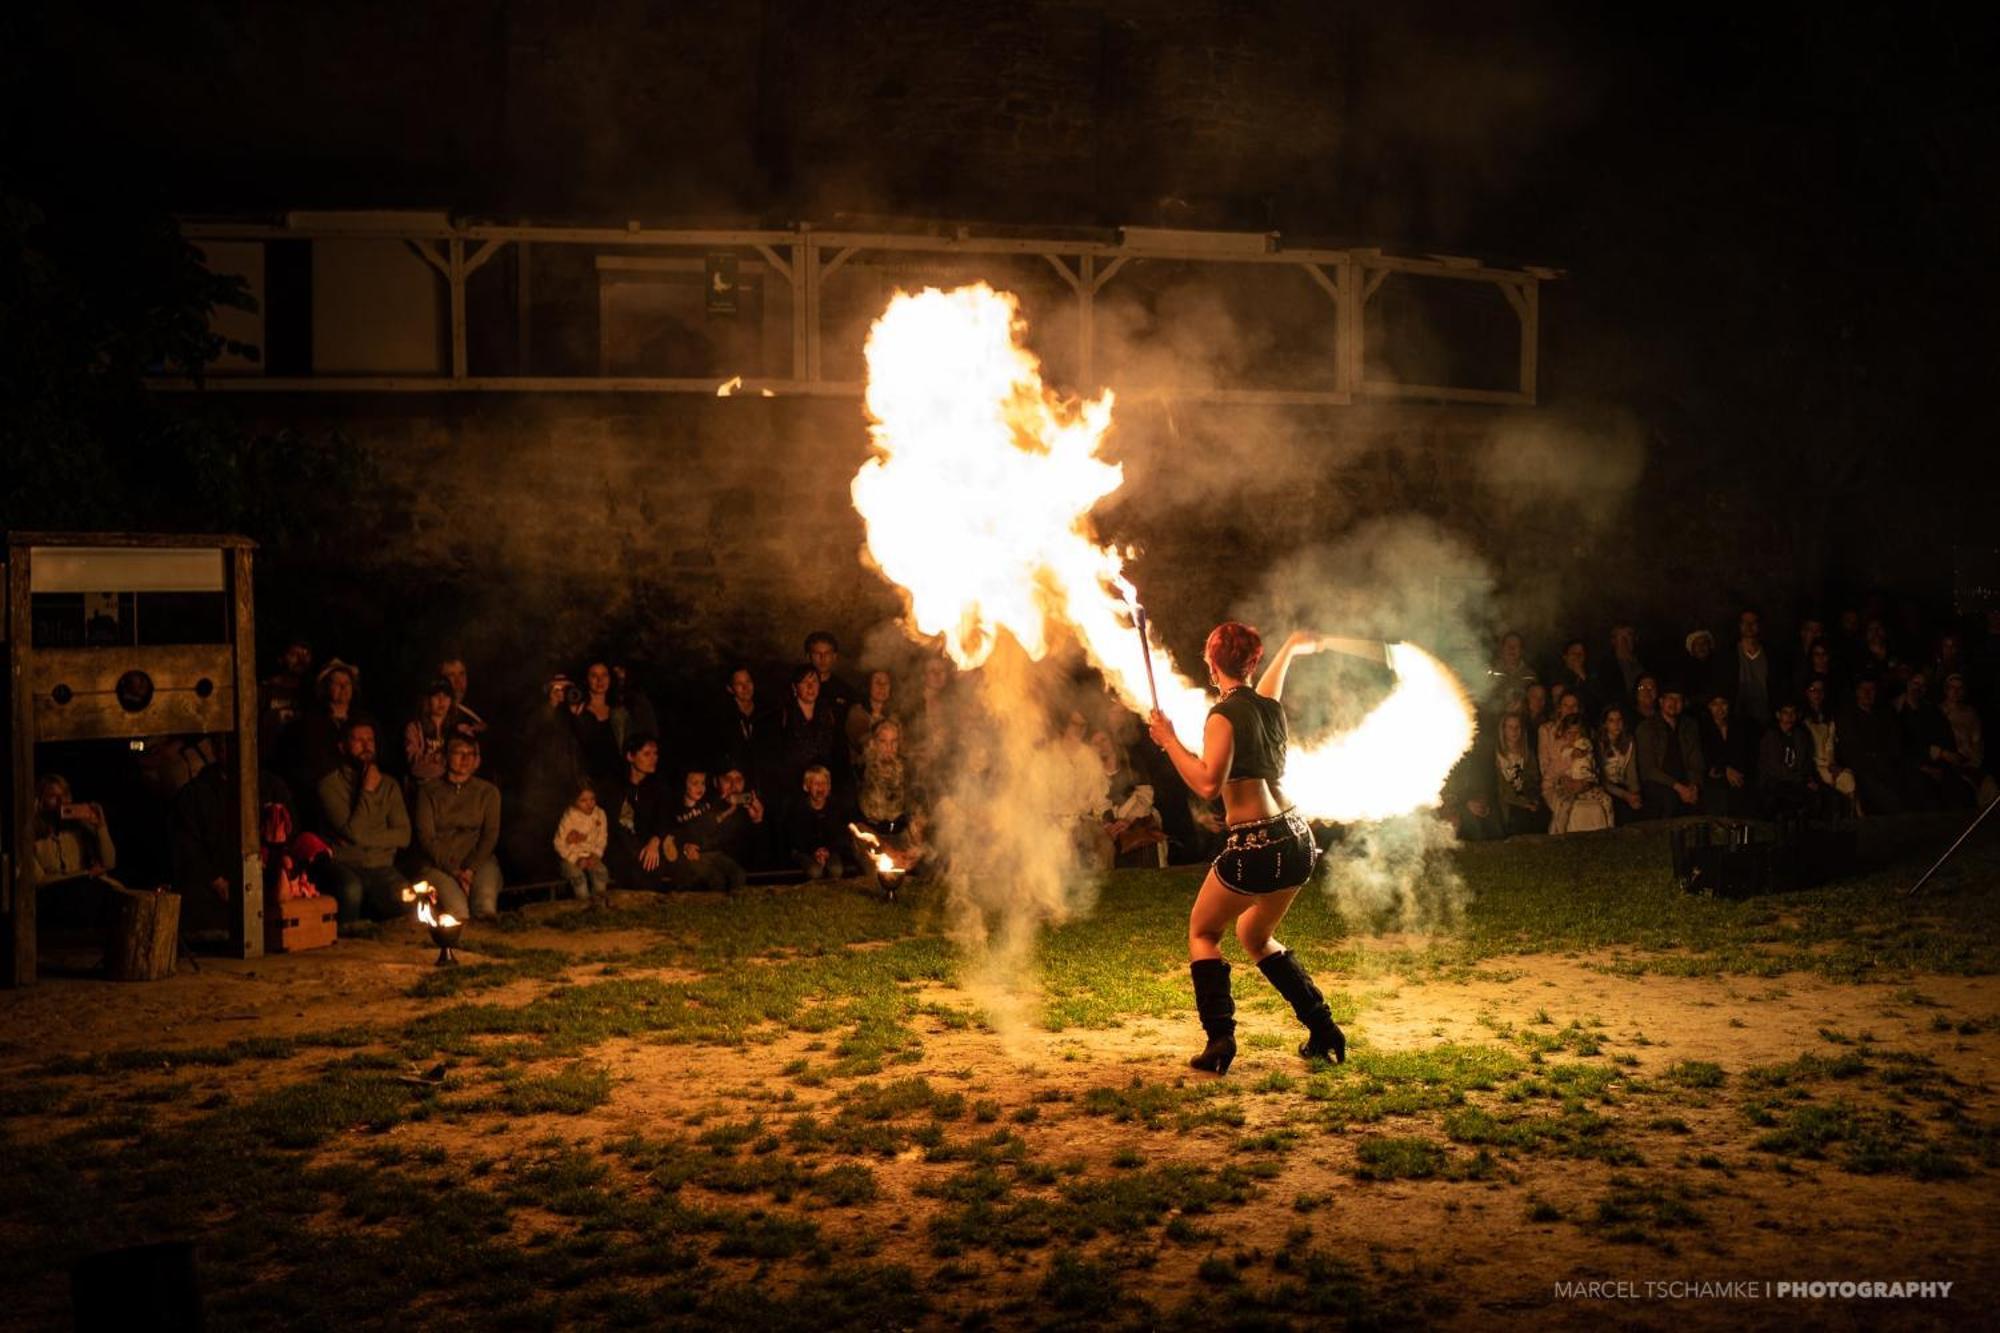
[0,188,366,546]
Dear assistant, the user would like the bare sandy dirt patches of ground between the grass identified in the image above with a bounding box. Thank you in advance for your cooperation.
[0,912,2000,1329]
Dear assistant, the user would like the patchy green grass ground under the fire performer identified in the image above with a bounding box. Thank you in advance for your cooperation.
[0,821,2000,1329]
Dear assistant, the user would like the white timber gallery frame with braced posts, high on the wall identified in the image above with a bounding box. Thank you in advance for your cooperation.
[154,214,1562,406]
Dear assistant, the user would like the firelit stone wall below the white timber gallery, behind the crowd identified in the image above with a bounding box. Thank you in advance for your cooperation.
[238,394,1596,712]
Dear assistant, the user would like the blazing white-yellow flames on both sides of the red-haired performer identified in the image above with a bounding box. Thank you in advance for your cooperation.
[854,282,1472,821]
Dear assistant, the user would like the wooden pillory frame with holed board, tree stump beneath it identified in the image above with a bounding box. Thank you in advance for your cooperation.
[0,532,266,987]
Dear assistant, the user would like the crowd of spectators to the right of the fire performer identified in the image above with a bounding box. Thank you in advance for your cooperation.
[1442,604,2000,841]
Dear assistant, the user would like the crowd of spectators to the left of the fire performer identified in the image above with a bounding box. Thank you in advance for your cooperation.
[27,632,1168,929]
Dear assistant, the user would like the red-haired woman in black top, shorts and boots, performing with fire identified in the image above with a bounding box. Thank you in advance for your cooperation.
[1152,620,1388,1073]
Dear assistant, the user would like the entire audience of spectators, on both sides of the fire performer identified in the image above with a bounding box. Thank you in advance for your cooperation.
[34,606,2000,931]
